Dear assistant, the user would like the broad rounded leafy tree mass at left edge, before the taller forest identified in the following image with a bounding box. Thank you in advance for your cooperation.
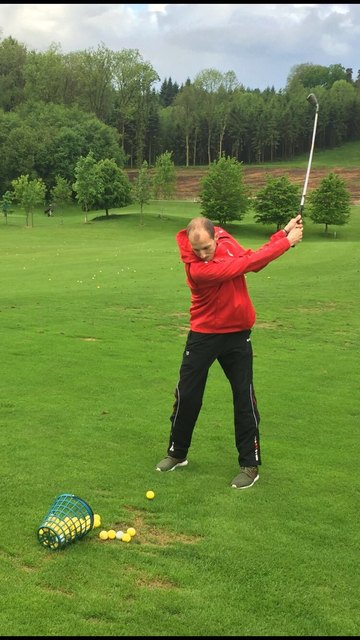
[0,100,125,193]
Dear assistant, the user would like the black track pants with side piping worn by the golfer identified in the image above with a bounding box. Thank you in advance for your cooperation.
[168,331,261,467]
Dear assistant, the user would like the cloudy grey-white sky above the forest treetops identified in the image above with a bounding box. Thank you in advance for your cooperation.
[0,4,360,91]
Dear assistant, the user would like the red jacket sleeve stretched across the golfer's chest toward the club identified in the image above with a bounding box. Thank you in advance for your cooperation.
[187,231,290,285]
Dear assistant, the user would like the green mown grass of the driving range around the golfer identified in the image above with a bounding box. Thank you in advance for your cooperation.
[0,202,360,636]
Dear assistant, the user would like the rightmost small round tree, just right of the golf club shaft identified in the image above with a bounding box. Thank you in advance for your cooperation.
[308,173,350,233]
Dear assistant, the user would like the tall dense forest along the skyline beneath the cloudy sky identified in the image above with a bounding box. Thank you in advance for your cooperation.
[0,37,360,188]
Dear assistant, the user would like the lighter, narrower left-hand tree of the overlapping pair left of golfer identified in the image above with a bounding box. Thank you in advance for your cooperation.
[73,151,104,222]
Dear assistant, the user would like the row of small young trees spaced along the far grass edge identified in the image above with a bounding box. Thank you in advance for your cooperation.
[1,152,350,230]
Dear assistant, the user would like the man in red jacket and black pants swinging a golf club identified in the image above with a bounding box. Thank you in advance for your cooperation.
[156,214,303,489]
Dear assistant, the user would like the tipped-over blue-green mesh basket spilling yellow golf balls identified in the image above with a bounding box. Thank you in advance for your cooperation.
[37,493,94,549]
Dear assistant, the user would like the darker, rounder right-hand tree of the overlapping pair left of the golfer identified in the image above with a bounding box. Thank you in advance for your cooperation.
[94,158,132,216]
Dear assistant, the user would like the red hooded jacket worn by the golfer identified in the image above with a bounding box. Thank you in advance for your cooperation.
[176,227,290,333]
